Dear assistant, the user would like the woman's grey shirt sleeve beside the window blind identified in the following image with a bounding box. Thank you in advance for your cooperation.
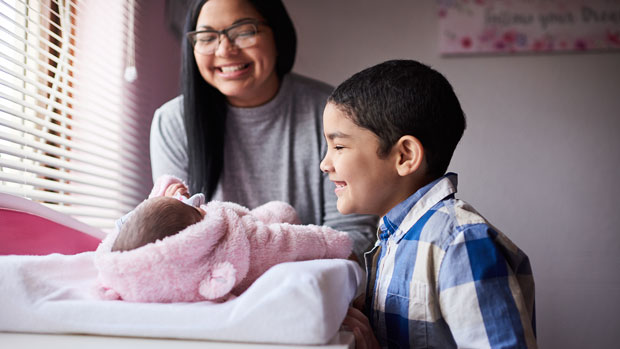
[150,97,188,182]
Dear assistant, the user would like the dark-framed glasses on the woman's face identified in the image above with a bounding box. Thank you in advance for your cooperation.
[186,20,266,55]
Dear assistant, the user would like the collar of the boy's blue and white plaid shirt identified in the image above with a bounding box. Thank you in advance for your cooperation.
[377,172,458,243]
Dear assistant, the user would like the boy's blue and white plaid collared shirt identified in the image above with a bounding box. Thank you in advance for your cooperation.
[365,173,537,348]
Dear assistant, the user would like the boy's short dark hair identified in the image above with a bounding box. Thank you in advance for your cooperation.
[328,60,465,178]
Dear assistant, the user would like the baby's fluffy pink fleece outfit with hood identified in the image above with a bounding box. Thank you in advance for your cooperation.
[95,176,352,303]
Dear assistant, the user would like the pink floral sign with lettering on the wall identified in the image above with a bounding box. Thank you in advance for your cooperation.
[438,0,620,55]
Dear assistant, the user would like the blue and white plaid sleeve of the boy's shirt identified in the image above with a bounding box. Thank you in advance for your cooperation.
[438,224,536,348]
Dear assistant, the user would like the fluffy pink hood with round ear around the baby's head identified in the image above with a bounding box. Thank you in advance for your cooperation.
[95,203,250,302]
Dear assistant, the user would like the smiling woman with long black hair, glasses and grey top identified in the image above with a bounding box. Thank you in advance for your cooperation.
[151,0,377,260]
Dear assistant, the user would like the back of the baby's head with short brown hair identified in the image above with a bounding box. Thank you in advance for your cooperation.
[112,196,202,251]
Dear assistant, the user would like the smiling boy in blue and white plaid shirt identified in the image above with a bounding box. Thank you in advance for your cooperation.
[321,60,536,348]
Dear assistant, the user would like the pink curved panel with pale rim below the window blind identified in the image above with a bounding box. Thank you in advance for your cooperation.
[0,193,106,255]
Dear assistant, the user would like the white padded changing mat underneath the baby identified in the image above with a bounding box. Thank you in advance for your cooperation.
[0,252,364,344]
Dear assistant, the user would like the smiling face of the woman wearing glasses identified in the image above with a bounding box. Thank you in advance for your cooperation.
[194,0,279,107]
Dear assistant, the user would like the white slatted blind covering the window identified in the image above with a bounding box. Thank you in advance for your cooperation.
[0,0,150,229]
